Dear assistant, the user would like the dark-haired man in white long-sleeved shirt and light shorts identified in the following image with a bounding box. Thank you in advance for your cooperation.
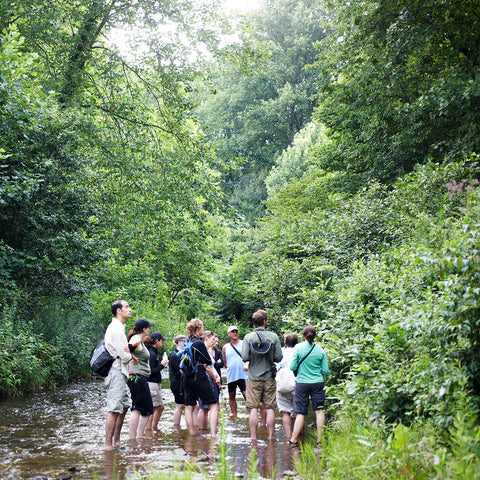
[105,300,135,450]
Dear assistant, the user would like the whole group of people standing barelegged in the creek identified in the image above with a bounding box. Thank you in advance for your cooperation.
[105,300,329,450]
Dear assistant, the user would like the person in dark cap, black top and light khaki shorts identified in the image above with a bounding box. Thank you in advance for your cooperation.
[144,332,168,430]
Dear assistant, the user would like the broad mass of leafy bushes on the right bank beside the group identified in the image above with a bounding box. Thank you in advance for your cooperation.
[250,155,480,430]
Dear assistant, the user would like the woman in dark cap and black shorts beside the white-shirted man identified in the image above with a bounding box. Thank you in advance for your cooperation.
[127,318,155,440]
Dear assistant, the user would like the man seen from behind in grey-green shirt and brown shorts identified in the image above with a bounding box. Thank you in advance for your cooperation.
[242,310,283,440]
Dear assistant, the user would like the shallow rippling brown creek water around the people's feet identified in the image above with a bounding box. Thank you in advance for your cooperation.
[0,379,308,480]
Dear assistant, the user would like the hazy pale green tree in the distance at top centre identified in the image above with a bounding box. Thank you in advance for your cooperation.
[197,0,328,224]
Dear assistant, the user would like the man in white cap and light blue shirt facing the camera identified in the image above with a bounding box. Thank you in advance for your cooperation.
[222,325,247,418]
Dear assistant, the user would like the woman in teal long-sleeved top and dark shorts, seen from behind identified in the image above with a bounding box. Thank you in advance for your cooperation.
[288,326,329,445]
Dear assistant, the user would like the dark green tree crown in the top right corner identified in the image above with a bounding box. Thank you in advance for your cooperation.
[315,0,480,182]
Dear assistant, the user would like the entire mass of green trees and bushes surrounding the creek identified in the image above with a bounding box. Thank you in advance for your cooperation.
[0,0,480,478]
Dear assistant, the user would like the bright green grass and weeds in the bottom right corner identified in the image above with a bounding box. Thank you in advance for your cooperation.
[308,385,480,480]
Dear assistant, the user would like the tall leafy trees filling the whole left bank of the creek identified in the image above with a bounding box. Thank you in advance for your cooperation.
[0,1,227,395]
